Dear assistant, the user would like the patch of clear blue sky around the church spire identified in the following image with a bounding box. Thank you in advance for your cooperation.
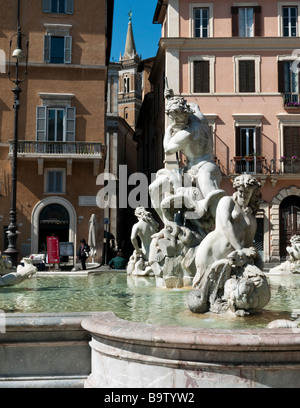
[110,0,161,62]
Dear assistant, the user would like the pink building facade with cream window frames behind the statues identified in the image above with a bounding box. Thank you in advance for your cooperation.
[154,0,300,262]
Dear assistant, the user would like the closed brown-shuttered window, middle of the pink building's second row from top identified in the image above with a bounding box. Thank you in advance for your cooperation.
[234,55,260,93]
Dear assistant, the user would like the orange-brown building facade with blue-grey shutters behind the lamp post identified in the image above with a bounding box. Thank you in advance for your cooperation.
[0,0,114,260]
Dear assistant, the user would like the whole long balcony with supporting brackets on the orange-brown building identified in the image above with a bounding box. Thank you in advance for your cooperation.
[8,140,106,176]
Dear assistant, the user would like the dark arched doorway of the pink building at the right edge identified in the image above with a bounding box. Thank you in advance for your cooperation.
[280,195,300,260]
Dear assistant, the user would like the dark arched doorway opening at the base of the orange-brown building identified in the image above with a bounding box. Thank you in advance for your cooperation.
[38,204,70,253]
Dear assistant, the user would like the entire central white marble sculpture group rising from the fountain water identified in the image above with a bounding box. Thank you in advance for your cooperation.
[127,89,270,316]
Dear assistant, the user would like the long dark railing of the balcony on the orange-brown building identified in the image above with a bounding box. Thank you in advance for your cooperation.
[9,140,104,158]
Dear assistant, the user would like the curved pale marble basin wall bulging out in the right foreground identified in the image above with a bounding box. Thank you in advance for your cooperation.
[82,312,300,388]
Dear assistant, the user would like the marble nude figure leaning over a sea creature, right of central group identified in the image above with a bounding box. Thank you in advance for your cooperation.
[187,175,271,315]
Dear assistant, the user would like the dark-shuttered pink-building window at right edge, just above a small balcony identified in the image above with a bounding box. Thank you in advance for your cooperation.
[278,61,299,104]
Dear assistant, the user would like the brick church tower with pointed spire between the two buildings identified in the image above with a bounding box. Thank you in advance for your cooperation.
[118,12,142,130]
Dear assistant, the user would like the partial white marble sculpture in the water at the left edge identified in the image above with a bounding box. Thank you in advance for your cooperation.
[0,252,37,287]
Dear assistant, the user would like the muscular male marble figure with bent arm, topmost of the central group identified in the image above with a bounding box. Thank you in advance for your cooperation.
[149,96,225,237]
